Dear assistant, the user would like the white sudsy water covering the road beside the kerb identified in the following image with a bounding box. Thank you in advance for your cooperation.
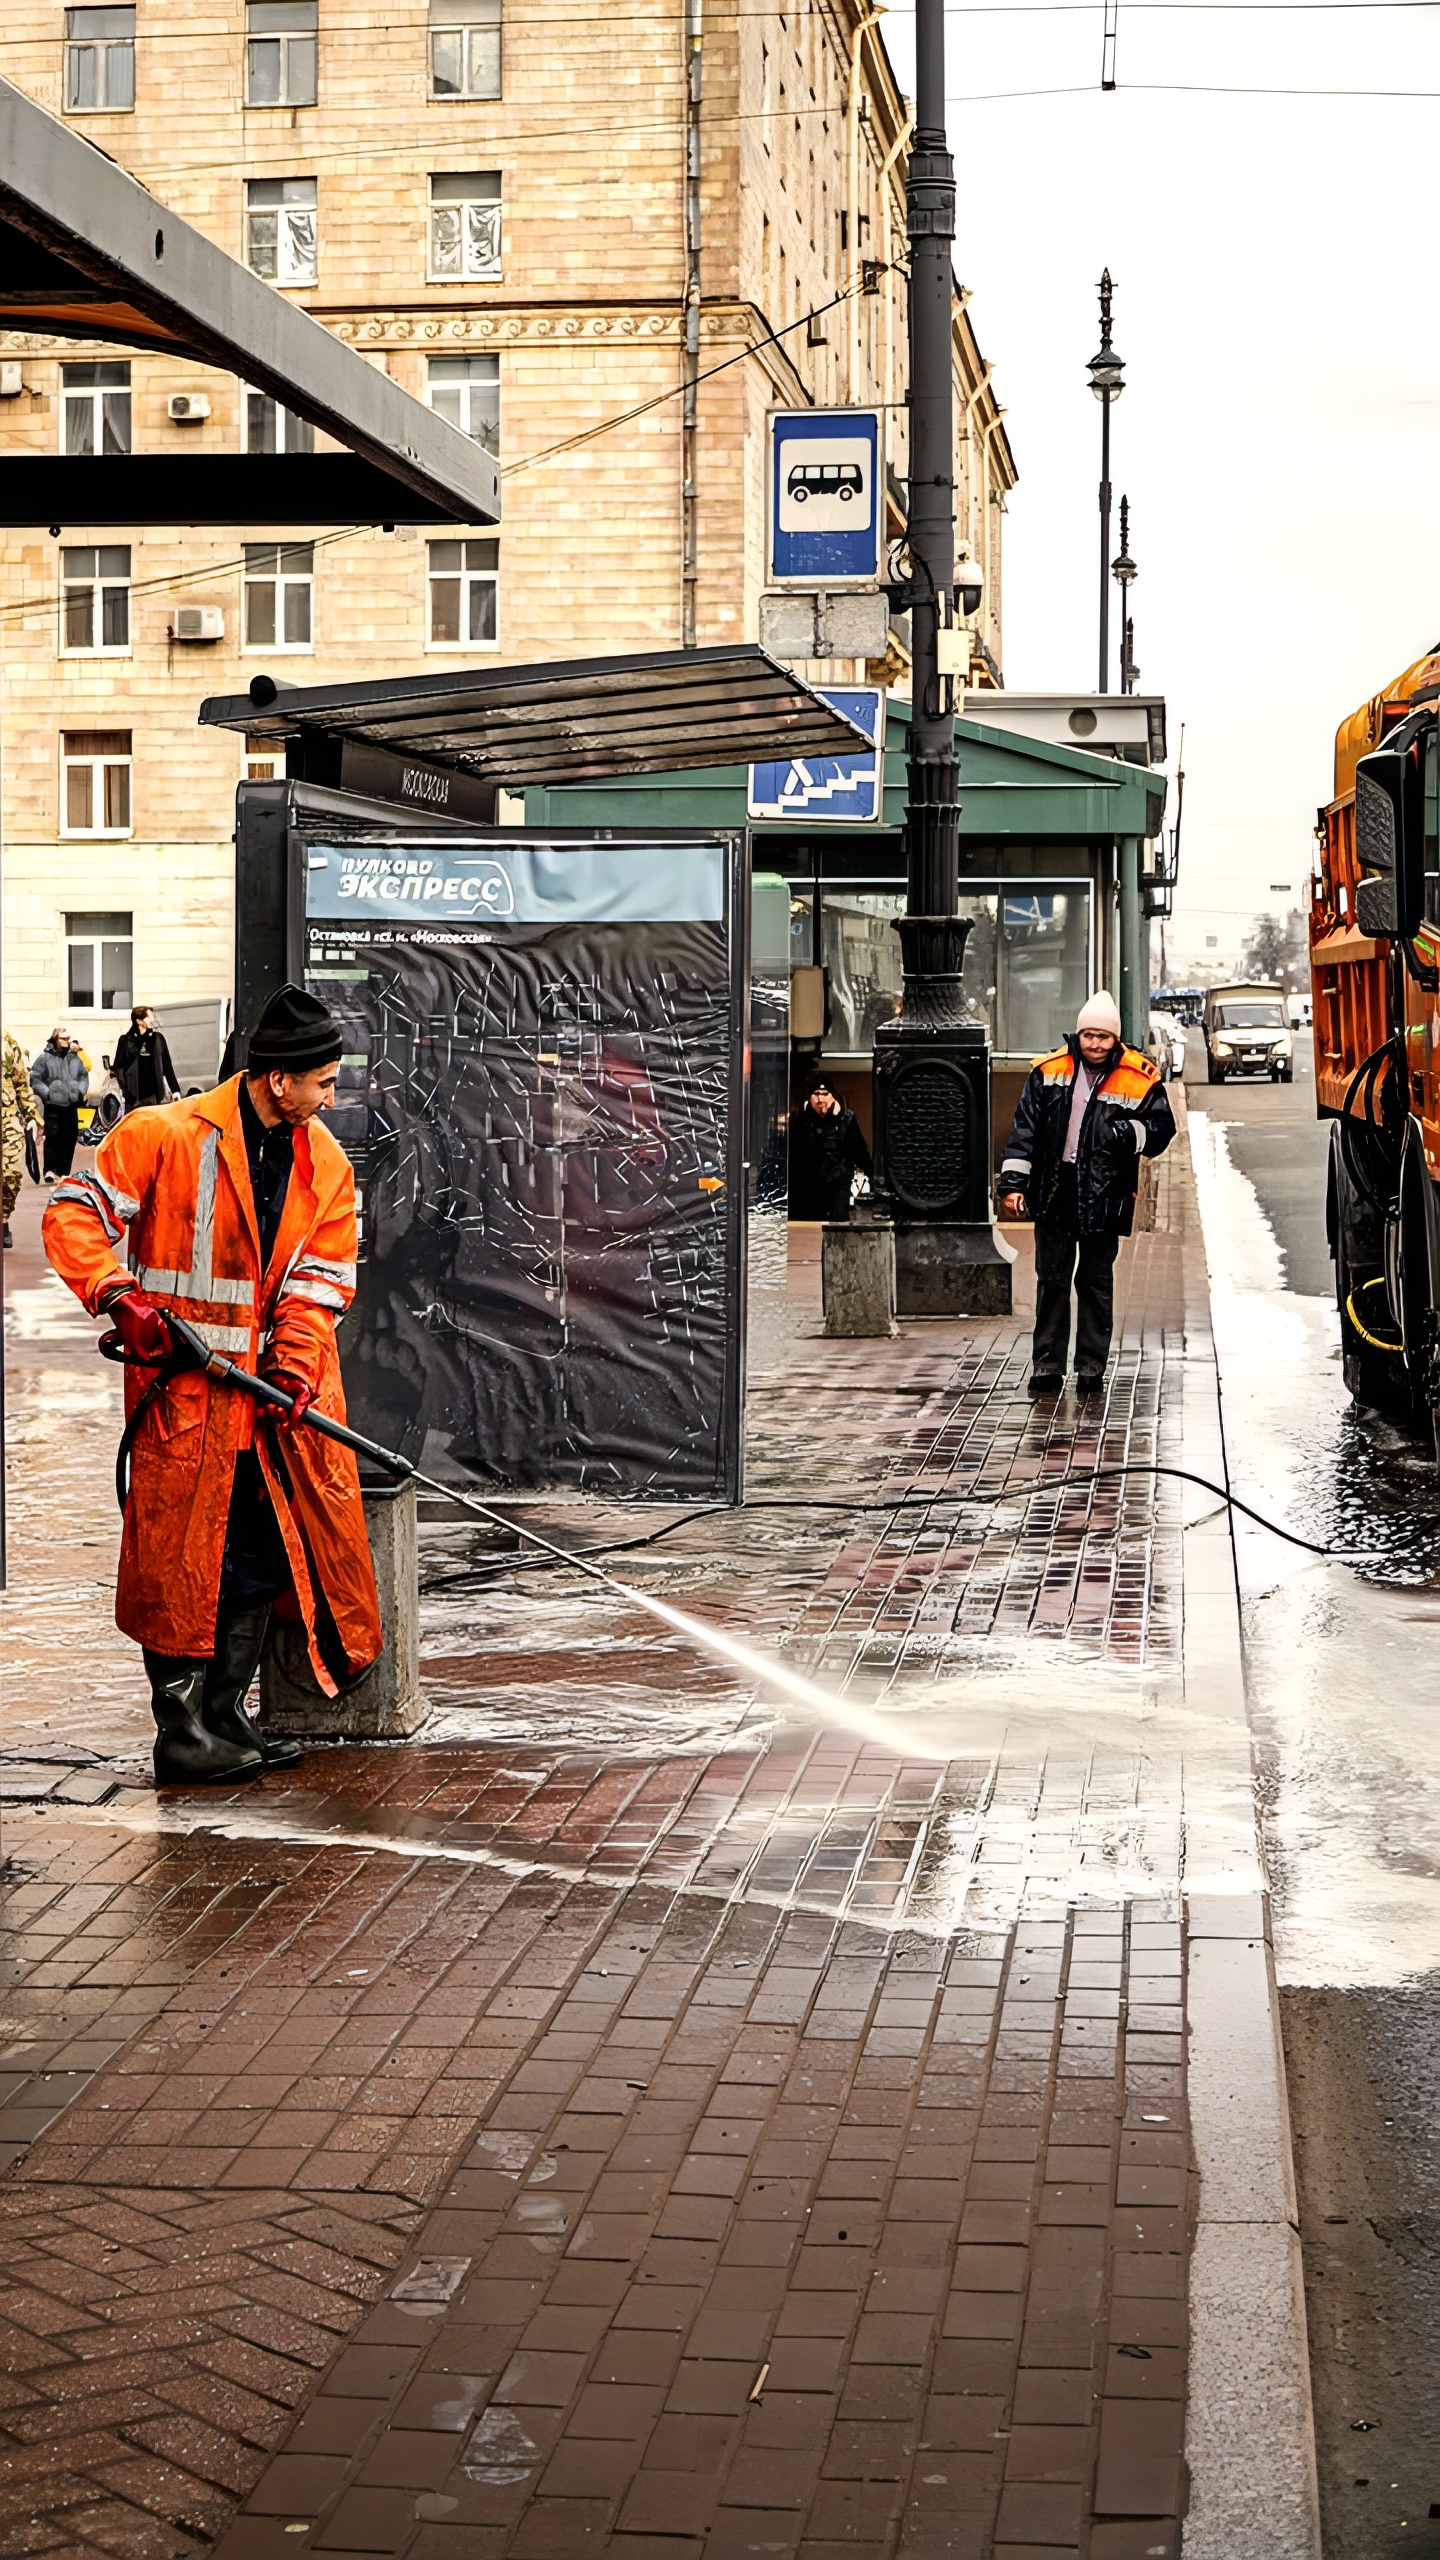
[1189,1108,1440,1984]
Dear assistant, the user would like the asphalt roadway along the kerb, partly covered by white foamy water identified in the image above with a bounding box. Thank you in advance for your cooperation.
[1189,1060,1440,2560]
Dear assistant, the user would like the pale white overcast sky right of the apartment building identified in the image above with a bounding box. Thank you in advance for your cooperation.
[884,0,1440,975]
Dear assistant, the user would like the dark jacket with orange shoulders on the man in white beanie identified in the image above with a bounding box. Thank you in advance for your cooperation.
[999,1034,1176,1236]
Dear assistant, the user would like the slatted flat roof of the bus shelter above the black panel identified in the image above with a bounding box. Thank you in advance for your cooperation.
[200,643,871,791]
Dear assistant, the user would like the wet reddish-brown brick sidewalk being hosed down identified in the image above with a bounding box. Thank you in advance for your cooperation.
[0,1149,1270,2560]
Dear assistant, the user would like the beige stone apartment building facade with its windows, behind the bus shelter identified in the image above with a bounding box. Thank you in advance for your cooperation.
[0,0,1015,1057]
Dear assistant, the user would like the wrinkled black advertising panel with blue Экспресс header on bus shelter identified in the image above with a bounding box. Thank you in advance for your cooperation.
[290,829,748,1500]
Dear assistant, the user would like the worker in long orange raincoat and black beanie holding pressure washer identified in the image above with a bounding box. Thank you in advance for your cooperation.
[44,986,382,1784]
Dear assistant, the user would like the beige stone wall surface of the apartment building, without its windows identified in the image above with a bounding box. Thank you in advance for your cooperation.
[0,0,1015,1055]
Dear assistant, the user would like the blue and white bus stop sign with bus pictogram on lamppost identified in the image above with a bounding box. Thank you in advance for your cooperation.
[766,410,884,586]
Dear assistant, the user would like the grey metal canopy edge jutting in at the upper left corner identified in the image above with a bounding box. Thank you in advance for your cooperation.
[0,79,500,525]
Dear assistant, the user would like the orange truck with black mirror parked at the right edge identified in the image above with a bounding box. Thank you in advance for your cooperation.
[1309,648,1440,1449]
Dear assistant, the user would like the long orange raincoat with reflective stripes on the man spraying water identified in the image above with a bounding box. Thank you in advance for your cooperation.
[44,1075,382,1695]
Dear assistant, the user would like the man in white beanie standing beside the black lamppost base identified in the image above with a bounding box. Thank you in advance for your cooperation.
[999,991,1176,1395]
